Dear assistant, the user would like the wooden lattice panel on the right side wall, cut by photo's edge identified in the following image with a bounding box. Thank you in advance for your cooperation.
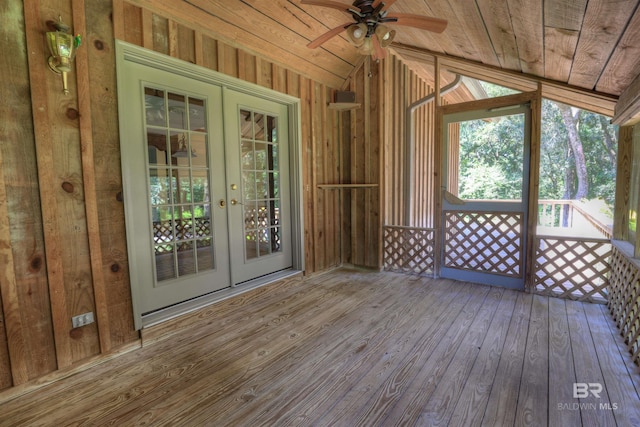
[608,248,640,365]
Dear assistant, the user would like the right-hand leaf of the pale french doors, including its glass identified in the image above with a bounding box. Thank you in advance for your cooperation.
[224,90,292,285]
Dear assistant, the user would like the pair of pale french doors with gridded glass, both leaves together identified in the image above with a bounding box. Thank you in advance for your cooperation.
[118,43,293,327]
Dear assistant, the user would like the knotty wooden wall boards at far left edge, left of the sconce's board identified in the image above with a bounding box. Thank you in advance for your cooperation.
[0,0,56,389]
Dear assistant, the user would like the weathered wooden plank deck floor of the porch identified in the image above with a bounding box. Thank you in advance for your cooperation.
[0,270,640,427]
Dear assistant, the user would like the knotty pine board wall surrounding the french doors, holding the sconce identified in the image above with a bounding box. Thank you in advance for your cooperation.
[0,0,402,392]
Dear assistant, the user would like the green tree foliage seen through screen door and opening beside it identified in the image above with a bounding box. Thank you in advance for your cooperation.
[459,82,618,217]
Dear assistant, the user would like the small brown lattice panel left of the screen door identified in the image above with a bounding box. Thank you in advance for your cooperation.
[384,226,435,275]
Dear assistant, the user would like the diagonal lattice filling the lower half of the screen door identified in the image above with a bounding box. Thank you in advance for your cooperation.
[444,211,523,277]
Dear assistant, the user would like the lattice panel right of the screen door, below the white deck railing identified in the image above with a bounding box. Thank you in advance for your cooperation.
[534,236,611,303]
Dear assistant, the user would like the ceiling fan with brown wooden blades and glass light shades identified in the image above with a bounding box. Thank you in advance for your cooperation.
[300,0,447,59]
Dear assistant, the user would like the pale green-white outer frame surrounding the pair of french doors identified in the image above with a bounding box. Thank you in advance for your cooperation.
[115,40,304,329]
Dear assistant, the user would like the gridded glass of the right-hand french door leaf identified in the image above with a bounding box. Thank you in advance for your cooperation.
[239,109,282,260]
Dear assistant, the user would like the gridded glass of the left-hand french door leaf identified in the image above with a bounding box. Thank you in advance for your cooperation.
[145,87,215,282]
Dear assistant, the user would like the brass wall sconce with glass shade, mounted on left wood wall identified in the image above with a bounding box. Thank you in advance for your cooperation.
[47,17,82,95]
